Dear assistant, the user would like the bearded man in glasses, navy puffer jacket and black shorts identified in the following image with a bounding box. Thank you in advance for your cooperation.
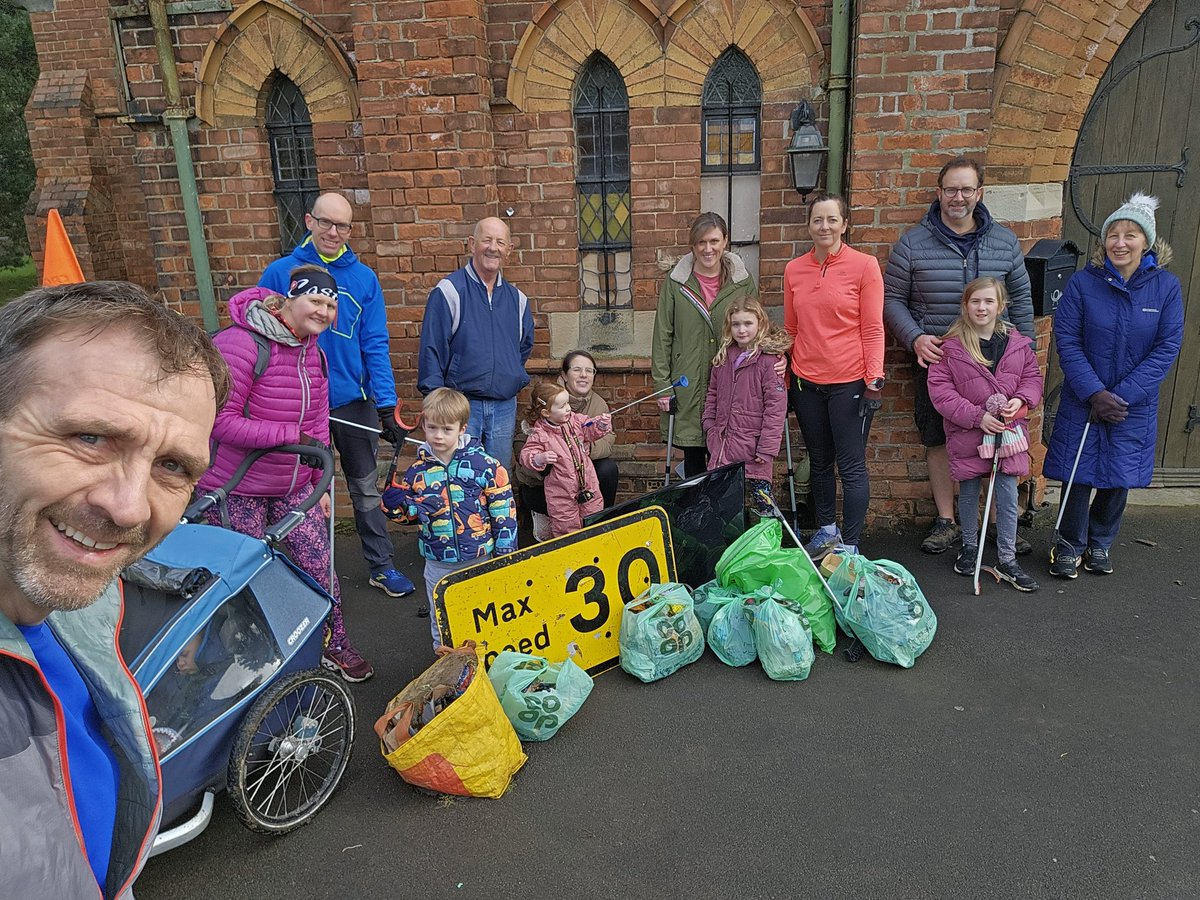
[883,156,1033,553]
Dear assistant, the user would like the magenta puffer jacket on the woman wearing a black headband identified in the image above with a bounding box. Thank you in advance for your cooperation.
[197,288,329,497]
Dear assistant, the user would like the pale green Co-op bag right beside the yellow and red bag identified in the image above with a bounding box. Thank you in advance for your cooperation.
[487,650,592,740]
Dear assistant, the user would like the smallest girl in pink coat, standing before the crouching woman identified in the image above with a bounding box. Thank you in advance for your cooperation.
[520,382,612,538]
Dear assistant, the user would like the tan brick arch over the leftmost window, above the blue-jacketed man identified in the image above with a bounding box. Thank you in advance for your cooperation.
[196,0,359,128]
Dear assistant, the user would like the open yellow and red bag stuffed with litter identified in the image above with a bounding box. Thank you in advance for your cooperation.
[374,641,527,798]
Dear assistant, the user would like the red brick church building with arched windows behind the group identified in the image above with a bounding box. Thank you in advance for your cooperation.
[23,0,1200,520]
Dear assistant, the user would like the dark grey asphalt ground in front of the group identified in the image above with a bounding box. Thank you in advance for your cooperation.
[136,506,1200,900]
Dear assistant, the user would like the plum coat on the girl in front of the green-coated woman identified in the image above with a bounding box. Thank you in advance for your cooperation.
[702,332,791,481]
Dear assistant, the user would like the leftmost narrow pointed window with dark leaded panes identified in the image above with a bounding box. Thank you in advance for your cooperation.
[266,72,318,253]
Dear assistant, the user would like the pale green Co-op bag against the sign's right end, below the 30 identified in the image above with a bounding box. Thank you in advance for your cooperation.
[619,582,704,682]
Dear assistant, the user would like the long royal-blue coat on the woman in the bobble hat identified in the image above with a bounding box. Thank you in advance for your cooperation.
[1043,254,1183,488]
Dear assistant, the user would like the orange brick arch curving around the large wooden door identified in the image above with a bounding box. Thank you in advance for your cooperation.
[986,0,1151,185]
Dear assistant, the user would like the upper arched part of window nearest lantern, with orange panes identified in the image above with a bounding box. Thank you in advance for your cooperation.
[701,47,762,172]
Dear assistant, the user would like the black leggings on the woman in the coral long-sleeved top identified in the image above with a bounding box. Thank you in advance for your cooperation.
[792,379,872,546]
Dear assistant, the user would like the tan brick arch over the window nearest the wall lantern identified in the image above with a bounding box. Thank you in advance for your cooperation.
[664,0,824,106]
